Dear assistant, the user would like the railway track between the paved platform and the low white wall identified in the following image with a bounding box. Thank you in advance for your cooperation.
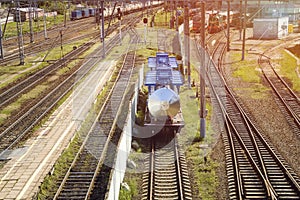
[54,27,138,199]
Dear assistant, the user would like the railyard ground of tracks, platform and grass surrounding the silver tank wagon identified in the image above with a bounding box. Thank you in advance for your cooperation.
[0,2,300,199]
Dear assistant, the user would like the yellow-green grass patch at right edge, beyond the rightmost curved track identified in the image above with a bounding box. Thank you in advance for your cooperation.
[280,51,300,92]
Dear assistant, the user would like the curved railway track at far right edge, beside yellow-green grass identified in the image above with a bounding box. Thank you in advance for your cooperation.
[258,54,300,136]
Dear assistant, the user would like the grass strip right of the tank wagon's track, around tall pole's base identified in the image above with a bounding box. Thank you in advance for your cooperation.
[180,85,218,199]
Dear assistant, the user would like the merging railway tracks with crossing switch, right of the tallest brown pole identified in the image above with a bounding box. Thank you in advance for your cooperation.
[203,38,300,199]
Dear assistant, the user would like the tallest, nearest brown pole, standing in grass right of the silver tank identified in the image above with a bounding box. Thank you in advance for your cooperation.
[199,1,206,138]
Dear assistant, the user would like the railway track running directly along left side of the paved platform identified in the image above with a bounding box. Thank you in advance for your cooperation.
[0,12,139,157]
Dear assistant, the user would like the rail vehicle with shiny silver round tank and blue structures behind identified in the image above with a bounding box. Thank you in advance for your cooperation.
[145,52,184,133]
